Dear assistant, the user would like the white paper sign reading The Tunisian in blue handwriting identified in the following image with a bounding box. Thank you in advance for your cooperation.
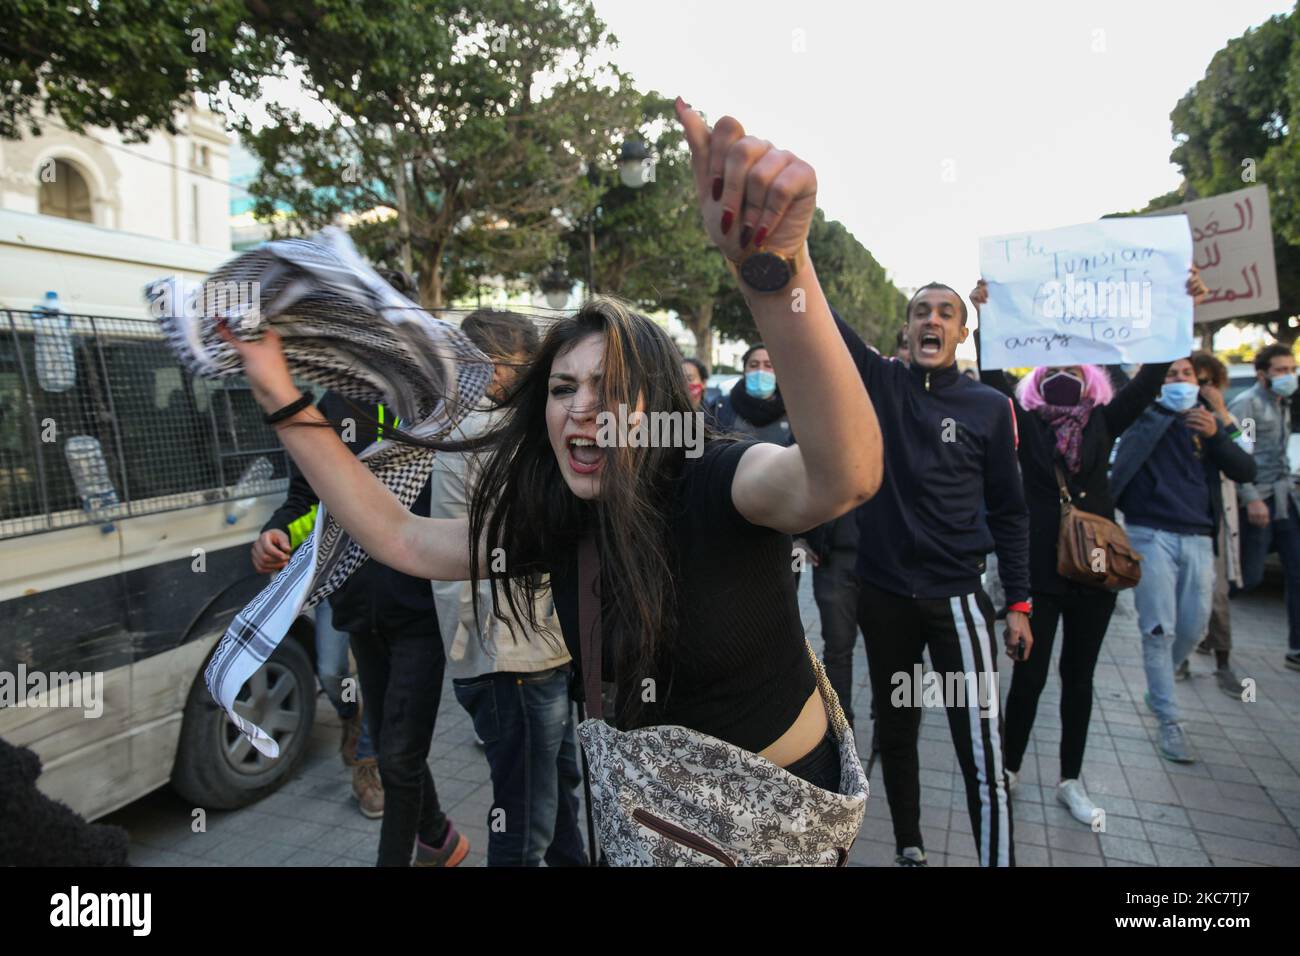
[979,216,1192,368]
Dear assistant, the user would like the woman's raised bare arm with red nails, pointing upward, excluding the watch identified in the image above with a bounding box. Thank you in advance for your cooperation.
[677,98,884,533]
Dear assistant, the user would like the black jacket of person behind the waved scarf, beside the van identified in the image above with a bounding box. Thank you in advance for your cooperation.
[263,392,438,633]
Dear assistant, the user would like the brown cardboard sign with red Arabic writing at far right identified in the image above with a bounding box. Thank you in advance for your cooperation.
[1147,186,1278,323]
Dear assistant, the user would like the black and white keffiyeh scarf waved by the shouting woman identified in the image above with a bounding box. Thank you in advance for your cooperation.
[146,228,493,757]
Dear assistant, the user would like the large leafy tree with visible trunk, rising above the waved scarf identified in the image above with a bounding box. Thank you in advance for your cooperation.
[237,0,636,307]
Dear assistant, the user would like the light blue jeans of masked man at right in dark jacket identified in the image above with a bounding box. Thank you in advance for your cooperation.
[1128,524,1214,723]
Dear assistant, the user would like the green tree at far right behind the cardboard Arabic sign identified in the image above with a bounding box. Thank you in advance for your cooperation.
[1144,13,1300,345]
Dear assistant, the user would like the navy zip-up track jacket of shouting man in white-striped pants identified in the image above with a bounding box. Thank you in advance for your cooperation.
[836,316,1030,604]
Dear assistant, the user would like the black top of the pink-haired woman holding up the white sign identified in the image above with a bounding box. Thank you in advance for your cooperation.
[980,353,1170,594]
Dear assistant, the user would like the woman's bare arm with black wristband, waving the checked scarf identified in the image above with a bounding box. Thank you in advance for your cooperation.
[221,326,469,580]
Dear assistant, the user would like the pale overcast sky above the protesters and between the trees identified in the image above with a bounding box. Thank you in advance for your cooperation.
[595,0,1290,294]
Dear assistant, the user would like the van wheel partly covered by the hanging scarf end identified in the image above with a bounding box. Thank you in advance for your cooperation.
[172,637,316,810]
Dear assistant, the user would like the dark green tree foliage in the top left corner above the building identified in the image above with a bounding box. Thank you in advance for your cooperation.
[0,0,276,142]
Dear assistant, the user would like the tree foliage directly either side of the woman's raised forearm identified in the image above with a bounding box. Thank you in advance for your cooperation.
[714,209,907,351]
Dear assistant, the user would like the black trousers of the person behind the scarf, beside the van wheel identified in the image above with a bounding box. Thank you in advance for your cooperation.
[351,611,447,866]
